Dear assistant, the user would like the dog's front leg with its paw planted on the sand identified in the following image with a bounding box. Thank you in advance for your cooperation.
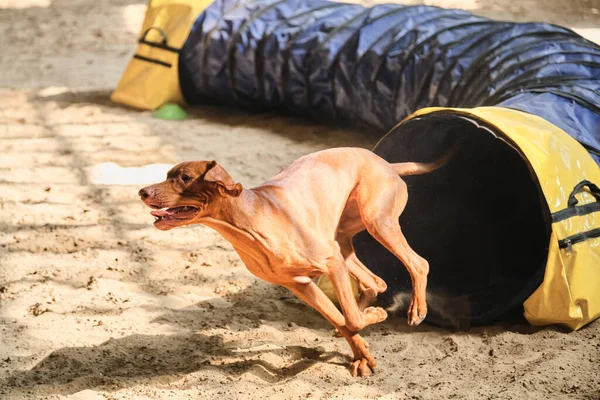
[286,281,377,376]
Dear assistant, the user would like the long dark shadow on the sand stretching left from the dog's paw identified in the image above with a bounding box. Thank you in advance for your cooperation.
[0,333,345,395]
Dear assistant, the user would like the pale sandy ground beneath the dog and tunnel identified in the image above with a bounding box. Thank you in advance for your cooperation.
[0,0,600,400]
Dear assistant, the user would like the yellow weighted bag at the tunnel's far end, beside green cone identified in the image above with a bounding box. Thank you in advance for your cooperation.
[111,0,212,110]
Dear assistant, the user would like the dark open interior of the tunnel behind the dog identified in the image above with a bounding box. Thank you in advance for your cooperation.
[354,111,551,328]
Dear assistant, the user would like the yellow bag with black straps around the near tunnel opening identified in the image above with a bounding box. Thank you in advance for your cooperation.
[410,107,600,329]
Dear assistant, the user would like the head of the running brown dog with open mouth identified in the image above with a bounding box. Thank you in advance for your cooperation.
[138,161,242,230]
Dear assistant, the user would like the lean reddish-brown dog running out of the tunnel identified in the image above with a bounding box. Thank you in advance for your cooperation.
[139,148,454,376]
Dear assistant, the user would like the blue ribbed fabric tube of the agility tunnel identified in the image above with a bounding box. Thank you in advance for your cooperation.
[179,0,600,164]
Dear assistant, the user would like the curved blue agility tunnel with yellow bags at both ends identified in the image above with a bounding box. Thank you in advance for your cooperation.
[112,0,600,329]
